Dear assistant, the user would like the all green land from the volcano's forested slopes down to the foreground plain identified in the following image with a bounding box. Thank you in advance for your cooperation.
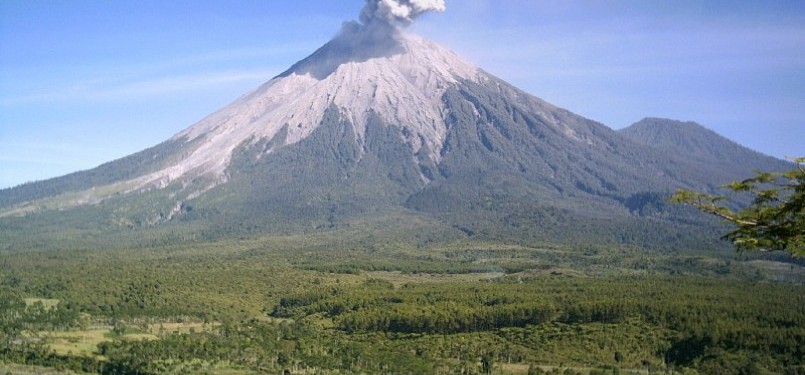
[0,49,805,375]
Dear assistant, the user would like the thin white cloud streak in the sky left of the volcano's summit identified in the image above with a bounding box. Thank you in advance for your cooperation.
[0,43,312,106]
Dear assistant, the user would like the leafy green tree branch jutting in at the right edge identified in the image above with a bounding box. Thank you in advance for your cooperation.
[671,157,805,257]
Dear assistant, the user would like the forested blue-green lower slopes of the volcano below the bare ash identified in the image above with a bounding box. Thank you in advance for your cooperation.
[0,107,789,258]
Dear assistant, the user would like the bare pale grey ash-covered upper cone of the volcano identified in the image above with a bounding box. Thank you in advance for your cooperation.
[166,35,484,187]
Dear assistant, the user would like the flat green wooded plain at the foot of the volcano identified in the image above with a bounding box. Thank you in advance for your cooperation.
[0,236,805,375]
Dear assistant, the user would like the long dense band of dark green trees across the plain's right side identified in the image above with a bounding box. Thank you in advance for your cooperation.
[273,277,805,333]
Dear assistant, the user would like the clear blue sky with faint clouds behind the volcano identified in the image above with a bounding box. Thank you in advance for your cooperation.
[0,0,805,188]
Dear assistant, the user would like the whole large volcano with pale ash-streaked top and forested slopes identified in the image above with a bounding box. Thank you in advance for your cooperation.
[0,23,788,253]
